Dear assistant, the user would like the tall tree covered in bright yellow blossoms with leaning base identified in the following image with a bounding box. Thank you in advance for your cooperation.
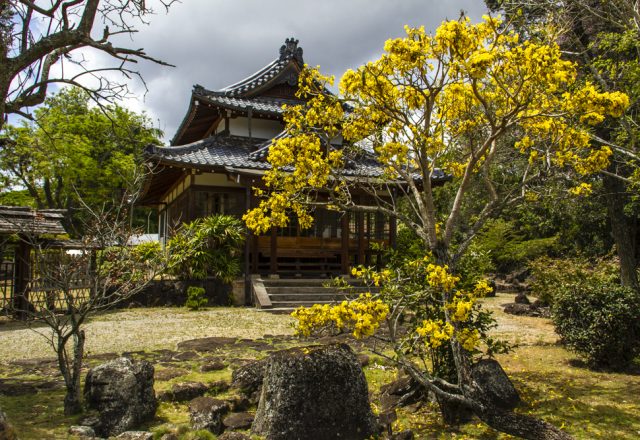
[245,17,628,438]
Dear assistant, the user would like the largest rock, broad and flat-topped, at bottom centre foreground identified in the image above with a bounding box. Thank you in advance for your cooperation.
[252,344,376,440]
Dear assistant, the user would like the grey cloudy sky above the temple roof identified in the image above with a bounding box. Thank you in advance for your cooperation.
[114,0,486,143]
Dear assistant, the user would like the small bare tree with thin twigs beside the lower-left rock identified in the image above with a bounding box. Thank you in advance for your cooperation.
[5,168,167,414]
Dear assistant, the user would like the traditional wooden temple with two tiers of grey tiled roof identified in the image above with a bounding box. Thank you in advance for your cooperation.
[141,38,444,306]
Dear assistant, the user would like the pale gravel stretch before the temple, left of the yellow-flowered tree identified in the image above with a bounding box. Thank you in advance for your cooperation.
[0,308,293,363]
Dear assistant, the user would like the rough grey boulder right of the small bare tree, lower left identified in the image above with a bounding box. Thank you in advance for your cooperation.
[84,357,158,437]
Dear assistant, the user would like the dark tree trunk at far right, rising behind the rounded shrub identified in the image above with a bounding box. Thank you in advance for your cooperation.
[602,170,638,288]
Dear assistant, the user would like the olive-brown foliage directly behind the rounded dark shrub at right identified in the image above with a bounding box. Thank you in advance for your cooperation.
[529,257,620,305]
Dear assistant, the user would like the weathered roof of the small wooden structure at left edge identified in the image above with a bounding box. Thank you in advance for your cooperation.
[0,206,67,235]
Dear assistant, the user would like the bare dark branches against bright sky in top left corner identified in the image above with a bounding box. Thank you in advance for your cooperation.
[0,0,176,129]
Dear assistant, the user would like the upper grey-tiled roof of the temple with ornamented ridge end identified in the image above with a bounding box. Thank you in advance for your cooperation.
[171,38,304,145]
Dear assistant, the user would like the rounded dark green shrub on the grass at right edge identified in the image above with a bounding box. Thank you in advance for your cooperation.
[553,277,640,370]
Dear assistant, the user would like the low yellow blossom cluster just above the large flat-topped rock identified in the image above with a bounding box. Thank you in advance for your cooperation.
[291,293,389,338]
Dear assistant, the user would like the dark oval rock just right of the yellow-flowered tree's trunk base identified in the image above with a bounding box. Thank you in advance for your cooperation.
[471,359,520,411]
